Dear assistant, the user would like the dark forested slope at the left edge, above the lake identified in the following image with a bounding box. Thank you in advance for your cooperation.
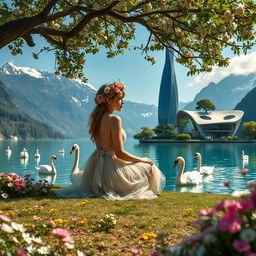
[0,81,63,139]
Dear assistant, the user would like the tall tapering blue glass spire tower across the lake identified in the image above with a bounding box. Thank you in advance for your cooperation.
[158,48,178,125]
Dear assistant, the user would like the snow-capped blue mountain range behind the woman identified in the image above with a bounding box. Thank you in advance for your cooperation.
[0,63,157,138]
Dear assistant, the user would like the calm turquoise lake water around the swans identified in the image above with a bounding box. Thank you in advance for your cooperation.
[0,139,256,193]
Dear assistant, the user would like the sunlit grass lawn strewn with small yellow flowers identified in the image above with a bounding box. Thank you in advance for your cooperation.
[0,192,230,256]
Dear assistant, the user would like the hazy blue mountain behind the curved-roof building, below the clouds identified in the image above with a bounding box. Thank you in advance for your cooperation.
[183,73,256,110]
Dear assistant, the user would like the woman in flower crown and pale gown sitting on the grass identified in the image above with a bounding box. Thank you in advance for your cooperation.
[56,82,165,200]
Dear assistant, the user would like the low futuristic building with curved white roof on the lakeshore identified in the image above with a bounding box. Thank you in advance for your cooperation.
[177,110,244,139]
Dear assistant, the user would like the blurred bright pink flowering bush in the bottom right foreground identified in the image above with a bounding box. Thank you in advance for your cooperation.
[152,182,256,256]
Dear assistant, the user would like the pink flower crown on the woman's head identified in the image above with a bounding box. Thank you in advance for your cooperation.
[94,82,125,104]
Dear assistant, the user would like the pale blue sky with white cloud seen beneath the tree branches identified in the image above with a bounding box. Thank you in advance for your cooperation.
[0,27,256,106]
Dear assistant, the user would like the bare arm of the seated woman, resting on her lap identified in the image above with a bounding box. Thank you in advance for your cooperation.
[110,115,153,165]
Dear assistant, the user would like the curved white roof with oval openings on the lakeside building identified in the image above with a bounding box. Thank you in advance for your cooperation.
[177,110,244,125]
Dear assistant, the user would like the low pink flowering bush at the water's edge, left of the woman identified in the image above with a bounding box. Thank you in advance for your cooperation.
[0,173,52,199]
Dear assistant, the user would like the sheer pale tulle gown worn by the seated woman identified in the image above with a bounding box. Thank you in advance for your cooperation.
[56,130,165,200]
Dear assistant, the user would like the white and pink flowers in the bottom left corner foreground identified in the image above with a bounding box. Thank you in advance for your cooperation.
[0,215,85,256]
